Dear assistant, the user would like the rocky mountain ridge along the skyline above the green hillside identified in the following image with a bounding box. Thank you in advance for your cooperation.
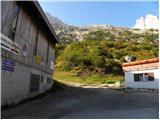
[46,13,158,44]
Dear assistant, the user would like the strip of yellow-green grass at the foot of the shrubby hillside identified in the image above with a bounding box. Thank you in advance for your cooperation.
[54,70,124,84]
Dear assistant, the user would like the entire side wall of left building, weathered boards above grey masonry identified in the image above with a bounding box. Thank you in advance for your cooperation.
[1,1,55,105]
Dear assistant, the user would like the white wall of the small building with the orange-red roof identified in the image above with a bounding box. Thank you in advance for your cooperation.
[125,69,159,89]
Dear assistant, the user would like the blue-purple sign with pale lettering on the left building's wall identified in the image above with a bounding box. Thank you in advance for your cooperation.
[2,60,14,72]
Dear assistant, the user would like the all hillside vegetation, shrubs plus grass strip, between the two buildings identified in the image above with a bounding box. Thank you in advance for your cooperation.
[54,30,158,84]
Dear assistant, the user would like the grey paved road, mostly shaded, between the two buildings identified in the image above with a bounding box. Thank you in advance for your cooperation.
[2,87,159,119]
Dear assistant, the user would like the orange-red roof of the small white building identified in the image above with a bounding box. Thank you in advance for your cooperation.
[122,58,159,71]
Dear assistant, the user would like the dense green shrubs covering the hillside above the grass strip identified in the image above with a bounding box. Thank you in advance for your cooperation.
[56,30,159,81]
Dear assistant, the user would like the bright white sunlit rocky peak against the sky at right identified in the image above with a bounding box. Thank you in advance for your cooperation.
[134,14,159,29]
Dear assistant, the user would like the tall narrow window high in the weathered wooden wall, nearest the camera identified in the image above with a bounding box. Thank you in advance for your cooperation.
[9,3,20,40]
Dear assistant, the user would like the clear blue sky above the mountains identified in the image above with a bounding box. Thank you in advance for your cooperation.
[39,1,159,27]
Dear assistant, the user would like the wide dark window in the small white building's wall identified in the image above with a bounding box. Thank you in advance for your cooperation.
[134,73,154,82]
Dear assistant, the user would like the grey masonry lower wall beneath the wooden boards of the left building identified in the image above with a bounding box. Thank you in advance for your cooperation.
[1,58,53,105]
